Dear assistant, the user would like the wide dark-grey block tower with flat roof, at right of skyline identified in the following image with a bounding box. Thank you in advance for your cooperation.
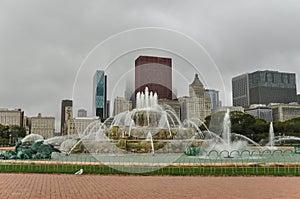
[232,70,297,107]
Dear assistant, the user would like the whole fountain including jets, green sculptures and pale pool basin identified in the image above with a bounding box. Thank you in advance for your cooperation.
[0,88,300,173]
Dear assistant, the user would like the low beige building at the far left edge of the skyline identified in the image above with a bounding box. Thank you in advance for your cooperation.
[0,109,25,127]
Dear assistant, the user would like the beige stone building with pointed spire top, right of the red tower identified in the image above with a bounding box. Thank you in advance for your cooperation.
[179,74,211,125]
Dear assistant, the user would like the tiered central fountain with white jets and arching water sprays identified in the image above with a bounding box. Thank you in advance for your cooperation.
[63,91,261,158]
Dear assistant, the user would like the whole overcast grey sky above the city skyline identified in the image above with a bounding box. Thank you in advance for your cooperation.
[0,0,300,131]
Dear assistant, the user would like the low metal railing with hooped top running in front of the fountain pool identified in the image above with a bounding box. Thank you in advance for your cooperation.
[0,149,300,176]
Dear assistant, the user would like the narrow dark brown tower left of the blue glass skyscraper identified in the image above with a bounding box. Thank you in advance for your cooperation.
[60,100,73,135]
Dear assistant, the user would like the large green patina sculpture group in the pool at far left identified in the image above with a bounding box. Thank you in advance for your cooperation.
[0,140,60,160]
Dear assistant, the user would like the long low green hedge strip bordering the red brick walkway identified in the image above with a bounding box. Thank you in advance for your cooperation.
[0,164,300,176]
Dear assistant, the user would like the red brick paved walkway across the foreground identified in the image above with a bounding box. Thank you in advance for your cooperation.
[0,173,300,199]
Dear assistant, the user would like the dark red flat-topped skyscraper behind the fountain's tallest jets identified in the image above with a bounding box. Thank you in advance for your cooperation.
[135,56,172,100]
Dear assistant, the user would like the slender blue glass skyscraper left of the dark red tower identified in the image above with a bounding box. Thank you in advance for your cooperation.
[93,70,108,121]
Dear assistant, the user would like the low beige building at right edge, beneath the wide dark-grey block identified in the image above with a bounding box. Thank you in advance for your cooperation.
[268,103,300,122]
